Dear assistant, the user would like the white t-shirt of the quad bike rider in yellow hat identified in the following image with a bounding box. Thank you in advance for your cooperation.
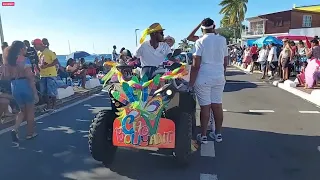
[135,41,172,67]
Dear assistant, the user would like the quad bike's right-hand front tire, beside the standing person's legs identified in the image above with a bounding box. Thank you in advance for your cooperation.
[166,108,193,166]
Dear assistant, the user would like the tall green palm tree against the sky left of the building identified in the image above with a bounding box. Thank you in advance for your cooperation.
[219,0,248,33]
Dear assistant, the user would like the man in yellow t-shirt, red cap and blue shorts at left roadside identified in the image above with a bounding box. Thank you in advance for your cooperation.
[33,39,59,111]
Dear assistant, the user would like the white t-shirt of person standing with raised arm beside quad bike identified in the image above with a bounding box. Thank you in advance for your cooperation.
[194,33,228,83]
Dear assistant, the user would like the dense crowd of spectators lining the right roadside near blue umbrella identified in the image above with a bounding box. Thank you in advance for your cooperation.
[229,36,320,88]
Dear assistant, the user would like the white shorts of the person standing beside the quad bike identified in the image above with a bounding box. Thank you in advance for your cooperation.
[194,79,226,106]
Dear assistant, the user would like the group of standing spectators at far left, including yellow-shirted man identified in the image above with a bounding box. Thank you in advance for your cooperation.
[0,38,59,142]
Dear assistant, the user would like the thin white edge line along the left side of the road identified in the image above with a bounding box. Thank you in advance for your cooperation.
[0,92,106,135]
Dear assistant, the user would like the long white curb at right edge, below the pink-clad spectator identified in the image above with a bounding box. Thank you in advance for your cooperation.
[272,81,320,106]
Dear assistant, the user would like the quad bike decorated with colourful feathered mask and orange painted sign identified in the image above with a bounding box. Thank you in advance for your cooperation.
[89,50,196,165]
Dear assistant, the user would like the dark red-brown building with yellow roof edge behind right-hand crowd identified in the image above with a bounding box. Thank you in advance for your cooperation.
[242,5,320,44]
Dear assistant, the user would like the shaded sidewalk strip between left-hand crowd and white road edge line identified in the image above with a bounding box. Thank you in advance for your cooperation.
[0,86,102,130]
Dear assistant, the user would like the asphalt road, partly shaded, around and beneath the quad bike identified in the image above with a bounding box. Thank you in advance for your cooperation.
[0,68,320,180]
